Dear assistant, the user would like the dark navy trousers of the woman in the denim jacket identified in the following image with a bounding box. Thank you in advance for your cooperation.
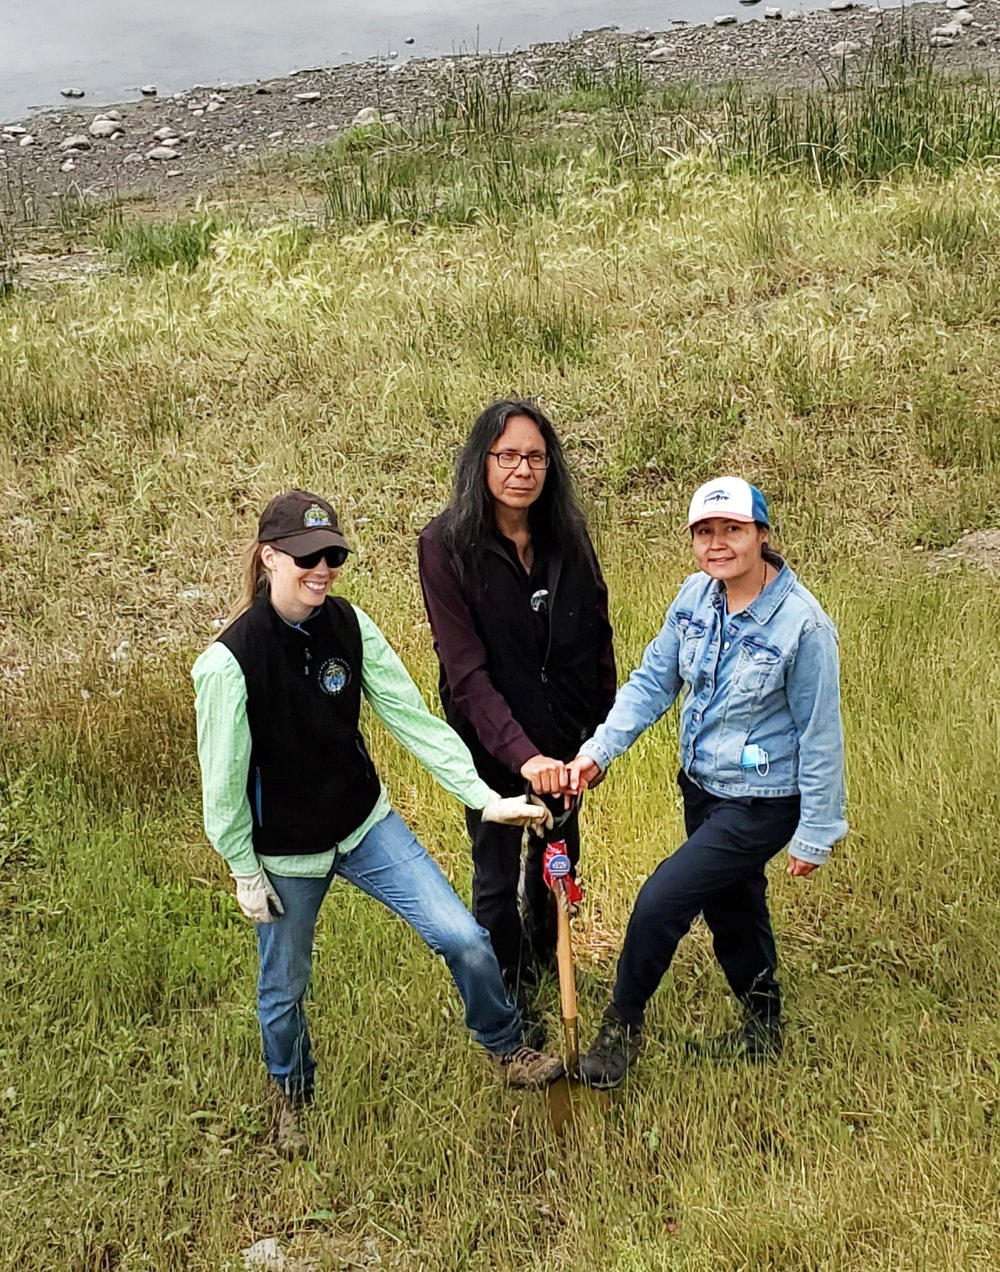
[612,772,799,1025]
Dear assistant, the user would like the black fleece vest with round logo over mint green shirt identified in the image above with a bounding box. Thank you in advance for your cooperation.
[219,595,380,856]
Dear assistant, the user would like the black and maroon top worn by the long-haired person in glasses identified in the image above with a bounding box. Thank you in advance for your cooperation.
[417,518,616,794]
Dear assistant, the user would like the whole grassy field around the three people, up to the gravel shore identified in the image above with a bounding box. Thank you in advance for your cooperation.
[0,39,1000,1272]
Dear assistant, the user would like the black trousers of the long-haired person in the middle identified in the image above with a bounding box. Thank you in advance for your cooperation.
[466,809,580,993]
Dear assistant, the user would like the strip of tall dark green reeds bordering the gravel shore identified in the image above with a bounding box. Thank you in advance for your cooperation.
[286,30,1000,236]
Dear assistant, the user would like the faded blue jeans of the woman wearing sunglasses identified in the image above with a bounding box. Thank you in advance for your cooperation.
[257,813,523,1100]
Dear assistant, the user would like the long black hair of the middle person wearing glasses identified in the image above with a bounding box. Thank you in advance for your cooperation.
[441,398,587,557]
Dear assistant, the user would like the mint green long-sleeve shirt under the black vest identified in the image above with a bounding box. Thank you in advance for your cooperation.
[191,605,490,878]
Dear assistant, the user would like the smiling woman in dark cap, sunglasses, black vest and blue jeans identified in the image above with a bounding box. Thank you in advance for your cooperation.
[192,490,562,1152]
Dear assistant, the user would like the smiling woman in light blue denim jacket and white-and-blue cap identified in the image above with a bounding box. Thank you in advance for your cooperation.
[569,477,847,1088]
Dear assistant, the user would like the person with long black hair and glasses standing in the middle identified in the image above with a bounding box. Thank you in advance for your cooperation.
[419,401,616,1037]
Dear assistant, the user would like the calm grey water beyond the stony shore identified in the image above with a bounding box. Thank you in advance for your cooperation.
[0,0,805,120]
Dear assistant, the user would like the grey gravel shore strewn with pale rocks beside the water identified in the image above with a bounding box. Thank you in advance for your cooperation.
[0,0,1000,209]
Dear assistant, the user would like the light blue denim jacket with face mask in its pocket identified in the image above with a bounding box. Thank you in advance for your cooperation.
[580,558,847,865]
